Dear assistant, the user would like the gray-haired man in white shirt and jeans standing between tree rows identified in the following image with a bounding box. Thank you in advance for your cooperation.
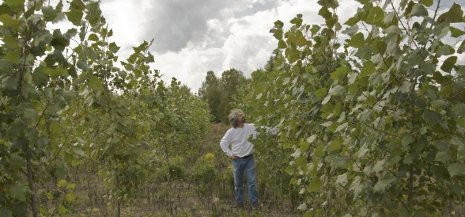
[220,109,259,208]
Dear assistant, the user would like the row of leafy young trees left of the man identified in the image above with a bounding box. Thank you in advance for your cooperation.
[0,0,210,216]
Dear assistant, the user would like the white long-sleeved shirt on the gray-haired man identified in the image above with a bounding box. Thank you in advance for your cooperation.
[220,124,257,157]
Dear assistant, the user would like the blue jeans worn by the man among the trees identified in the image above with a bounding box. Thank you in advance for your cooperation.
[233,156,258,204]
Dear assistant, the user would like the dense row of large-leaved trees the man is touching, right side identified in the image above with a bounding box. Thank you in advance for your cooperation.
[243,0,465,217]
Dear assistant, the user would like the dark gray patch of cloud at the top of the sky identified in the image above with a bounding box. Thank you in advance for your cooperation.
[136,0,276,53]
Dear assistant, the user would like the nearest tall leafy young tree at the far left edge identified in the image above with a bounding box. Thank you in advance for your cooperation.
[0,0,85,216]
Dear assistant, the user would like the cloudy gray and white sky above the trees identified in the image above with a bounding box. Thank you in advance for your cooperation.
[94,0,465,92]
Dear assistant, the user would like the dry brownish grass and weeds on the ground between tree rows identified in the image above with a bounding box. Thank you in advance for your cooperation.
[57,124,301,217]
